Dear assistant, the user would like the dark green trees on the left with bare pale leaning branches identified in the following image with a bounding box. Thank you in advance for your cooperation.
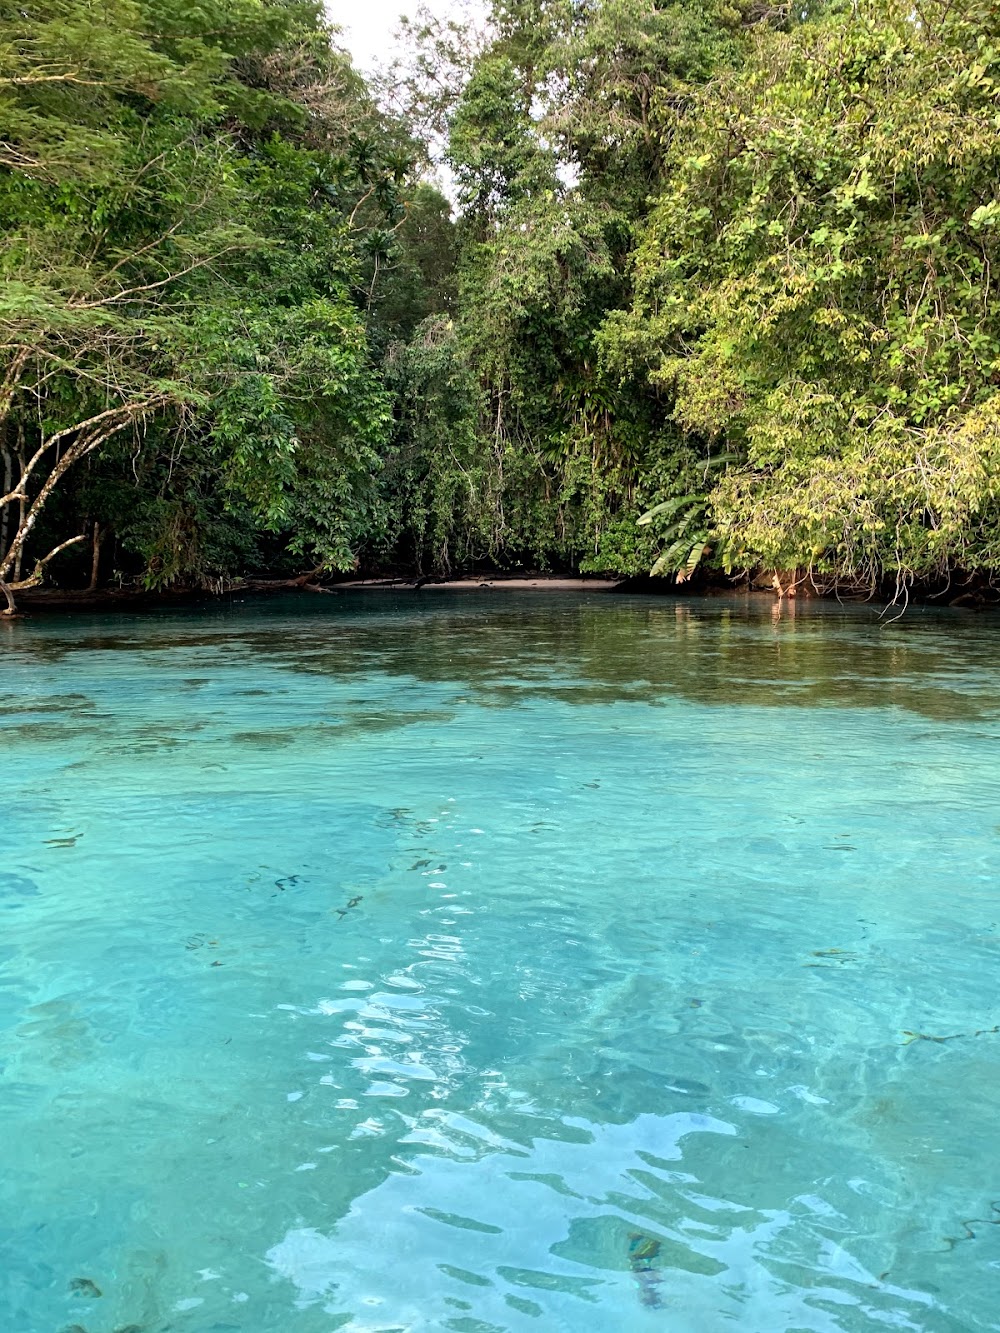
[0,0,405,609]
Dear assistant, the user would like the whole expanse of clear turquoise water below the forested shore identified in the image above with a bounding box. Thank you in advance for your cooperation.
[0,593,1000,1333]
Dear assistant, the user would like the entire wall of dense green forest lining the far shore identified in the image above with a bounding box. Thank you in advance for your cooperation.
[0,0,1000,602]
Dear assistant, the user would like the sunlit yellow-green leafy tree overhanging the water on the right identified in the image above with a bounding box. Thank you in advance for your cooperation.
[605,0,1000,587]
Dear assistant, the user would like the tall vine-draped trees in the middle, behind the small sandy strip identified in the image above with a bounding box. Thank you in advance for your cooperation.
[376,0,732,572]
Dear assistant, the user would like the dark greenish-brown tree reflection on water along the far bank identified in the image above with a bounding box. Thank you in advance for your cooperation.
[7,592,996,721]
